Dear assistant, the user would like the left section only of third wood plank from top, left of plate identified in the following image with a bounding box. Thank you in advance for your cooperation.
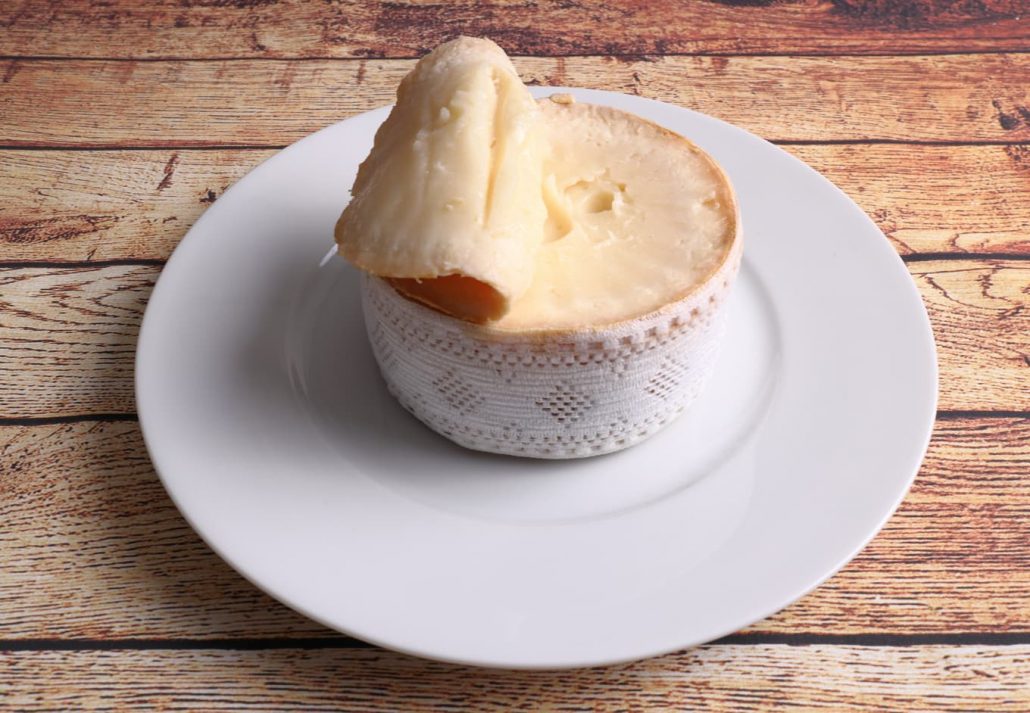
[0,149,271,262]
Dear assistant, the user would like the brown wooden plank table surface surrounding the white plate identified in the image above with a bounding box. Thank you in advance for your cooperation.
[0,0,1030,711]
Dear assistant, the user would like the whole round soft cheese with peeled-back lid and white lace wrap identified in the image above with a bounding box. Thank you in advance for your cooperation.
[336,38,743,459]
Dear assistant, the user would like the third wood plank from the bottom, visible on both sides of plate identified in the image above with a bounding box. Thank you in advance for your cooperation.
[0,260,1030,418]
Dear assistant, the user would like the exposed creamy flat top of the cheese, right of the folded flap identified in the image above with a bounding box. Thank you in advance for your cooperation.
[492,98,737,331]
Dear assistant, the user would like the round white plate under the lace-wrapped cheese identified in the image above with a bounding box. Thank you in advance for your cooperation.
[136,90,936,668]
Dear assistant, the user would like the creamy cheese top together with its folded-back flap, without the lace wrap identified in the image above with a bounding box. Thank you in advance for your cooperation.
[336,38,736,331]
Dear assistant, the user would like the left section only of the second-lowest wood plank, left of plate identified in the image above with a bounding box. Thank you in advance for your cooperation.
[0,421,329,638]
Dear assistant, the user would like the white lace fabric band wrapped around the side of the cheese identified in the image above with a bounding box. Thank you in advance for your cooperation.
[362,240,741,459]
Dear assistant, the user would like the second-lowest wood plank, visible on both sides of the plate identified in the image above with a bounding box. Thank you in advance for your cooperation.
[0,417,1030,640]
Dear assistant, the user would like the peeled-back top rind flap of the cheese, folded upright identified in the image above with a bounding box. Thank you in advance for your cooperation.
[336,37,546,321]
